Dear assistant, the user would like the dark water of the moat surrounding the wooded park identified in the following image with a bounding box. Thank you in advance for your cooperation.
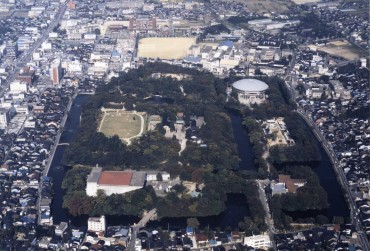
[48,96,348,229]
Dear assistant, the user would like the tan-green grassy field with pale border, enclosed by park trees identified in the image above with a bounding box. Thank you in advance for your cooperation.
[98,110,146,142]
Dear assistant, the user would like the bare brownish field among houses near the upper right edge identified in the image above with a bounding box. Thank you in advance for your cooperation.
[309,40,366,60]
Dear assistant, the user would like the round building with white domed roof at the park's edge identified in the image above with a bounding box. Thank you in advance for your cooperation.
[233,78,268,105]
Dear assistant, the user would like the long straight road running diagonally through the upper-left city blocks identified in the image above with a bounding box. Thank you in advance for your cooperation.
[0,4,67,97]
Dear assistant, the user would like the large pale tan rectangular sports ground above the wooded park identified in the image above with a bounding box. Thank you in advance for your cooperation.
[138,37,196,59]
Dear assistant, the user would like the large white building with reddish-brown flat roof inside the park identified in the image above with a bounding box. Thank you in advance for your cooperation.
[86,167,146,196]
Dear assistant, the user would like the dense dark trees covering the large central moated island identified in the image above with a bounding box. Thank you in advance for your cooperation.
[63,63,266,231]
